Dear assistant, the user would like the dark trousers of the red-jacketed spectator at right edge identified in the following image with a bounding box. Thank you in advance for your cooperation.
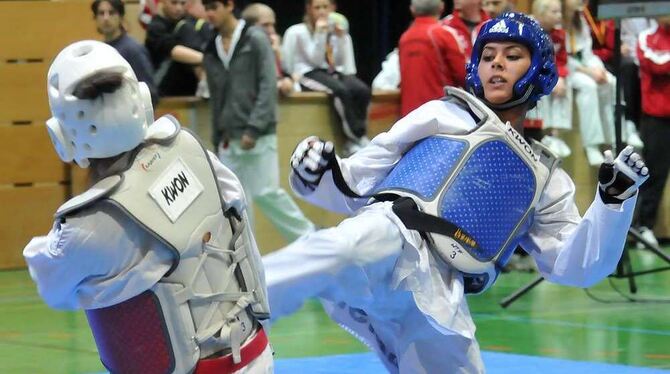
[637,114,670,229]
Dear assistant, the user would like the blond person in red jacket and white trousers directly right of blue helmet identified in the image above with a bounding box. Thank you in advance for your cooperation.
[532,0,572,158]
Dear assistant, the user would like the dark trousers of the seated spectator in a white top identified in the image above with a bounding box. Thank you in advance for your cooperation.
[300,70,371,141]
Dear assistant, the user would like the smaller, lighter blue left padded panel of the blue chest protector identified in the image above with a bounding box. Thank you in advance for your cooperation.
[376,136,466,201]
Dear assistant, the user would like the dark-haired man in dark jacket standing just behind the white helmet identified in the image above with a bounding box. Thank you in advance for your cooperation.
[91,0,158,106]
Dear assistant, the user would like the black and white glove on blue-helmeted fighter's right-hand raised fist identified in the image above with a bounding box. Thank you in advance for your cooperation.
[598,145,649,204]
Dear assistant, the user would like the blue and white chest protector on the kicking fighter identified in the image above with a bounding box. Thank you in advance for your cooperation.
[375,88,558,293]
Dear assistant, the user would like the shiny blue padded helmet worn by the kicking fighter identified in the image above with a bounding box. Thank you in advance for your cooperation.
[465,12,558,109]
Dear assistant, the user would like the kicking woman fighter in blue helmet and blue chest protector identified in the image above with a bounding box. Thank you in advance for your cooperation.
[263,13,648,373]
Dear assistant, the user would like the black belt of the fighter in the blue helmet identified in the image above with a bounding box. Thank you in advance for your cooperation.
[325,148,479,250]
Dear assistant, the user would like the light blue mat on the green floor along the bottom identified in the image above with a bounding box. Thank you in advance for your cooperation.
[275,352,668,374]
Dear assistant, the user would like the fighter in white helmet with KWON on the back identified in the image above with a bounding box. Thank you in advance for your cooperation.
[23,40,273,374]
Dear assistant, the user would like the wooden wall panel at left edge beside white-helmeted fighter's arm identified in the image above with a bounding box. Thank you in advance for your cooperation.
[0,183,65,269]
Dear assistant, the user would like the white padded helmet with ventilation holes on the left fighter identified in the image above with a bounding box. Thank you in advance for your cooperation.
[47,40,153,168]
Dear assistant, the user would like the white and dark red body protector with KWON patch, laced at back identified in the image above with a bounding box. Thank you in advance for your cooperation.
[57,116,269,373]
